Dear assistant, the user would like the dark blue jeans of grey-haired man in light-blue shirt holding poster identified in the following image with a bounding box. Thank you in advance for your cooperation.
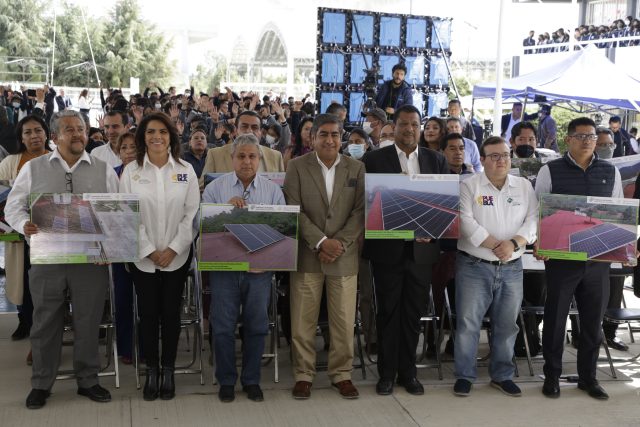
[209,271,272,385]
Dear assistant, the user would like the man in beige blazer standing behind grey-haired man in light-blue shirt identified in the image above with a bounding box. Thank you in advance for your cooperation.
[201,111,284,179]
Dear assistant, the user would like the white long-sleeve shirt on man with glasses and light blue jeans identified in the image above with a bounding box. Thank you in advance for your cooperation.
[458,172,538,261]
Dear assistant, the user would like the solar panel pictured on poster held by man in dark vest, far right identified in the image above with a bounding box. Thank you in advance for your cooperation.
[569,223,636,258]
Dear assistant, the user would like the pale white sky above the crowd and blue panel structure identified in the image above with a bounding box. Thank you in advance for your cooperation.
[71,0,578,70]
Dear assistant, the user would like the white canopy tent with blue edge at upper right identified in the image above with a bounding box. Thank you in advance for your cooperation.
[473,45,640,111]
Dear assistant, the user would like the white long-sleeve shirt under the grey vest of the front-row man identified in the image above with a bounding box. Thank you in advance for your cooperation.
[4,148,118,233]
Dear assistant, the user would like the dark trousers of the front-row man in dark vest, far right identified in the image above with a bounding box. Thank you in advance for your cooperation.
[542,260,610,382]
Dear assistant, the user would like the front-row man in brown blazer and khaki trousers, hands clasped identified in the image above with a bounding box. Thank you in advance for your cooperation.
[284,114,364,399]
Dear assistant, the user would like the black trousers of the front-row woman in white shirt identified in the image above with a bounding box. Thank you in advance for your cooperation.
[129,257,191,368]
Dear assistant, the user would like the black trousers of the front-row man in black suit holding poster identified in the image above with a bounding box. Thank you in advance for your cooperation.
[372,258,431,380]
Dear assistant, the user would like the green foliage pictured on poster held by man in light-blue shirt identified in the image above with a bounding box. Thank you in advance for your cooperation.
[202,208,298,238]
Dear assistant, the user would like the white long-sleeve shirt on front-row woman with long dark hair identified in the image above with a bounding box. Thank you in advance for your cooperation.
[120,155,200,273]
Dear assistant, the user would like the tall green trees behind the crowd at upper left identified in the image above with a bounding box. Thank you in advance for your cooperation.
[0,0,175,87]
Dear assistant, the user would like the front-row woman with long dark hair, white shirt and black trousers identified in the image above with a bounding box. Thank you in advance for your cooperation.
[120,113,200,400]
